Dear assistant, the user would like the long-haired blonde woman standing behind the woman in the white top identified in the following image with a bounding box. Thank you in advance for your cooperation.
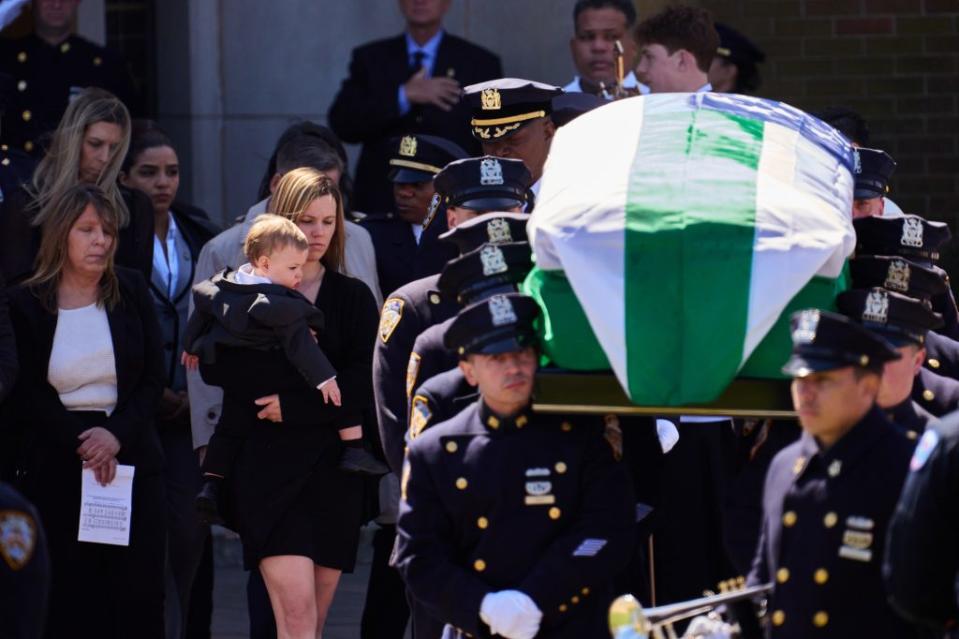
[0,87,153,284]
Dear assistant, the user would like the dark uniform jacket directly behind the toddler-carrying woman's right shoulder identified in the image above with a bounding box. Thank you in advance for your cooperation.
[362,213,457,298]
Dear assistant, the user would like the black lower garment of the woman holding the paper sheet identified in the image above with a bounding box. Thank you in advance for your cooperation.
[24,451,166,639]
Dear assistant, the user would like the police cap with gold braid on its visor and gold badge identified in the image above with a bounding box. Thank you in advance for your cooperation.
[463,78,563,142]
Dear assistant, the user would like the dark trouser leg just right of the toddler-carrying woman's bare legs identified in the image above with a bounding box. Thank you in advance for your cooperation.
[360,524,410,639]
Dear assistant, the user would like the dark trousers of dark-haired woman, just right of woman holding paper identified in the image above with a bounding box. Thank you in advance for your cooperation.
[159,422,210,639]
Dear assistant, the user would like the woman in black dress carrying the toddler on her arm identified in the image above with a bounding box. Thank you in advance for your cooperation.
[201,168,377,637]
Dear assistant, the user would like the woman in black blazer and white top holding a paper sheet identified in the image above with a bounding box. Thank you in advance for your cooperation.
[9,184,165,639]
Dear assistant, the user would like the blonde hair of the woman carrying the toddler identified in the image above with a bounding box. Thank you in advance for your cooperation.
[267,167,346,271]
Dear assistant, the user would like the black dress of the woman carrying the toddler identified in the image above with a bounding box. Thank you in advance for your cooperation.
[202,271,377,572]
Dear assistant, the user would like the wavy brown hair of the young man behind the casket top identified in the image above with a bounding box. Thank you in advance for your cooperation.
[636,5,719,73]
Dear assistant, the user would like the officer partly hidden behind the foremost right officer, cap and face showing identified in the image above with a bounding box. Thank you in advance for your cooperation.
[836,287,942,440]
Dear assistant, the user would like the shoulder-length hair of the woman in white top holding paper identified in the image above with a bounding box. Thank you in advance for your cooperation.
[24,184,120,313]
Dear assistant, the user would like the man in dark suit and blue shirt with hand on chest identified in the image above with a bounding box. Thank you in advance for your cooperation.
[329,0,503,215]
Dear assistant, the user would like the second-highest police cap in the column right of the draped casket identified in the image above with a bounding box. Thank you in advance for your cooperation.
[852,215,952,266]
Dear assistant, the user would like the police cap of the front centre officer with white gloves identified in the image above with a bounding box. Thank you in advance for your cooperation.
[443,293,540,358]
